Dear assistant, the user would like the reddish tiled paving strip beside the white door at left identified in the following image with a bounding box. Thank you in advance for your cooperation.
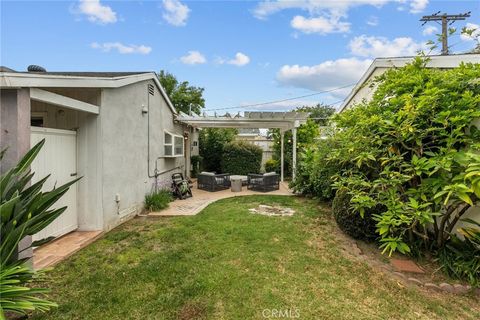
[33,231,102,270]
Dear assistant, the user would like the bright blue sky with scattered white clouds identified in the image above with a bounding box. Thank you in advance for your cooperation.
[0,0,480,112]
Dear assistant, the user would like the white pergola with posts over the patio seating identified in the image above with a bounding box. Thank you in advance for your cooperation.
[176,112,309,181]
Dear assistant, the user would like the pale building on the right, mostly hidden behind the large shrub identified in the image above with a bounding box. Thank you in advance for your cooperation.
[339,54,480,227]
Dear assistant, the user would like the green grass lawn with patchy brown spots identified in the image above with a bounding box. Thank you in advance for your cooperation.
[34,196,480,320]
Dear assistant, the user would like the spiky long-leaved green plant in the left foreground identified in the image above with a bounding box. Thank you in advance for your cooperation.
[0,140,80,320]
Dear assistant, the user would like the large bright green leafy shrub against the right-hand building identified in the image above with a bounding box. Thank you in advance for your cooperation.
[330,58,480,253]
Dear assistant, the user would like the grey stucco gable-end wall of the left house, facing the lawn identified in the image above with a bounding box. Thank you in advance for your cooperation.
[100,80,184,230]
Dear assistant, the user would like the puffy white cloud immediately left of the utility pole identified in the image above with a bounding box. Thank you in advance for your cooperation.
[349,35,424,58]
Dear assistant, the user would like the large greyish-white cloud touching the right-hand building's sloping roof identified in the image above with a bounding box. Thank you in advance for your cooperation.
[276,58,372,97]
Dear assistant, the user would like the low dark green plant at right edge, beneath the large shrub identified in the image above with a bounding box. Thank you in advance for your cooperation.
[438,219,480,287]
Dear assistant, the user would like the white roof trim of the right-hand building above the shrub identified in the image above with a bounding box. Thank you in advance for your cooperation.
[338,54,480,113]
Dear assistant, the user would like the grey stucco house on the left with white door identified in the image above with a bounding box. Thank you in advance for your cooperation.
[0,68,198,239]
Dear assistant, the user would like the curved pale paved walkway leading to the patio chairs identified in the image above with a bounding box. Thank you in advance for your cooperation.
[148,182,293,217]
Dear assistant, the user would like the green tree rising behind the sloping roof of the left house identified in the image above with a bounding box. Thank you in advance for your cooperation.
[158,70,205,114]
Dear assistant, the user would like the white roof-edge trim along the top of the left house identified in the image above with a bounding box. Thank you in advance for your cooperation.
[0,72,177,115]
